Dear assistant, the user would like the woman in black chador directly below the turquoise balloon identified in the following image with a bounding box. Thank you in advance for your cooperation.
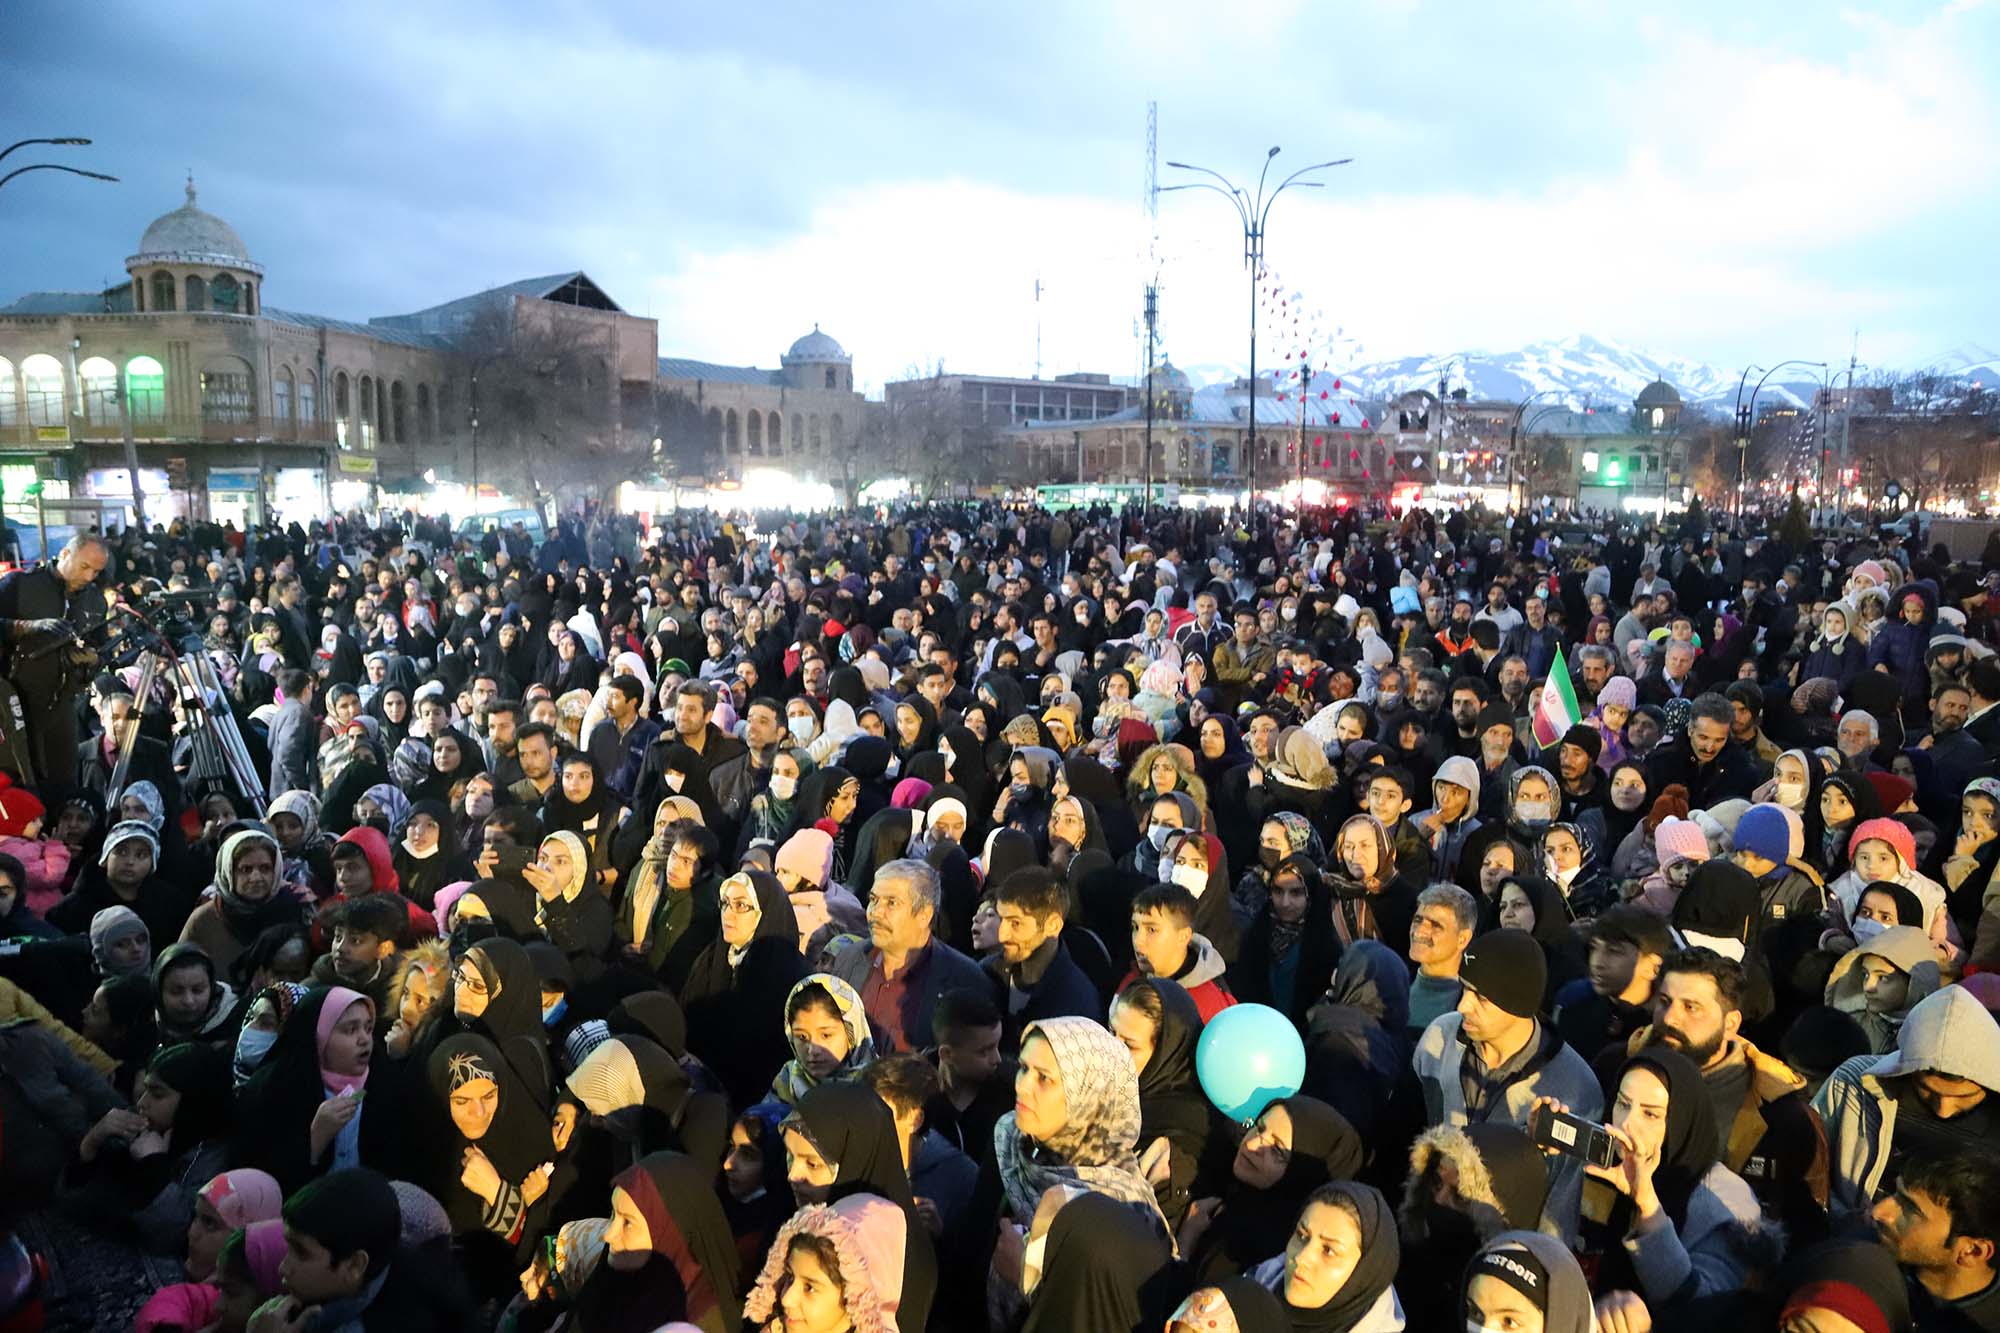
[1180,1095,1364,1281]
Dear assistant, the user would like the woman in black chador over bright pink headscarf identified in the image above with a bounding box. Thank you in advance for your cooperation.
[236,987,386,1195]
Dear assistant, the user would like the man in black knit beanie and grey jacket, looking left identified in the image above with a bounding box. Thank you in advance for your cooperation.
[1410,929,1604,1237]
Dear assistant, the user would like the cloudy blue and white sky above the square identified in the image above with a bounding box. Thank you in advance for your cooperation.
[0,0,2000,386]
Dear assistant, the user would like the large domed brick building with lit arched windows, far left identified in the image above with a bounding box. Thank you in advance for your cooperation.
[0,178,658,524]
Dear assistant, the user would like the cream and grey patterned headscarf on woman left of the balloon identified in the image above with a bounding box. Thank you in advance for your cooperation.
[994,1017,1178,1255]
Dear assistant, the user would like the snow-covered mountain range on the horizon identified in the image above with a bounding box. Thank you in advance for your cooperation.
[1182,334,2000,414]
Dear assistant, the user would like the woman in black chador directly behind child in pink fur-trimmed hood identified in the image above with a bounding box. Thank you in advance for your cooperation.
[774,1065,936,1333]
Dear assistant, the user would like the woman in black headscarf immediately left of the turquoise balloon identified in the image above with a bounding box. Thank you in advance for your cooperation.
[1110,977,1222,1227]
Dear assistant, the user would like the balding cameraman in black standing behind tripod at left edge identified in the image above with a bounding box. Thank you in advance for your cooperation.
[0,532,112,807]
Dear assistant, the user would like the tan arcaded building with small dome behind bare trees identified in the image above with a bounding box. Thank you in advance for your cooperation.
[660,324,866,484]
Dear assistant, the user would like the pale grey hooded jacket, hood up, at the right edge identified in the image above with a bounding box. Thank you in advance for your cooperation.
[1812,987,2000,1229]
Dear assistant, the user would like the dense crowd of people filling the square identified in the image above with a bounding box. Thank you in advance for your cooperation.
[0,504,2000,1333]
